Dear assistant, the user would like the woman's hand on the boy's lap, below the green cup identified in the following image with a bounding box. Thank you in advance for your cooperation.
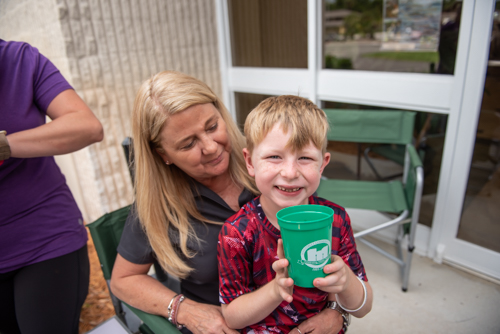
[290,308,344,334]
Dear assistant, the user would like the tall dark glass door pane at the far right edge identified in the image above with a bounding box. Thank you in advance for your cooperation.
[457,2,500,252]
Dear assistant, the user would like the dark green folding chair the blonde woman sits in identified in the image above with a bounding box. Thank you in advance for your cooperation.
[87,206,180,334]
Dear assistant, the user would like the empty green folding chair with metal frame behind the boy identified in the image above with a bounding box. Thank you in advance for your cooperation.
[317,109,424,291]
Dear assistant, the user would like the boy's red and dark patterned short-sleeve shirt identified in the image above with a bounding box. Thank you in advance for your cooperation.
[218,196,367,334]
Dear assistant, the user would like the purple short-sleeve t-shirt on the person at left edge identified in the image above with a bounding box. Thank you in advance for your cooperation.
[0,39,87,273]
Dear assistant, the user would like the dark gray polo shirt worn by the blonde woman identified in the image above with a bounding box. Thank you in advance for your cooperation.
[118,182,255,305]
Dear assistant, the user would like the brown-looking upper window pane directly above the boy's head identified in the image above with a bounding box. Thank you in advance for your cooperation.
[228,0,307,68]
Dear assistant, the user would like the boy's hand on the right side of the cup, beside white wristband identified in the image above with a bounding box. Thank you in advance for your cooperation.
[313,255,353,293]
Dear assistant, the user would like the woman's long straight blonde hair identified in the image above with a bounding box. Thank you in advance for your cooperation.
[132,71,258,278]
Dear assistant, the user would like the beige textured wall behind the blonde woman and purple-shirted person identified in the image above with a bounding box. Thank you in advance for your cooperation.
[0,0,221,222]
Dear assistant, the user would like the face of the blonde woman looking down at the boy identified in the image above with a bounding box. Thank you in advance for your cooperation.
[158,103,231,185]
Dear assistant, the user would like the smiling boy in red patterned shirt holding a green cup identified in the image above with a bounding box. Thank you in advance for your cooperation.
[218,96,372,334]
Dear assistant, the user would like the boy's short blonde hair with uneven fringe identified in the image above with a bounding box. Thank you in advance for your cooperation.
[244,95,329,153]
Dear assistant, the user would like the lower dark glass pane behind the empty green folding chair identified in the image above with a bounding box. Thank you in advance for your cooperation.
[323,101,447,227]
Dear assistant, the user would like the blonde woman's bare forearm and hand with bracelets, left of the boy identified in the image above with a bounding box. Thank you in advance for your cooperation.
[111,254,238,334]
